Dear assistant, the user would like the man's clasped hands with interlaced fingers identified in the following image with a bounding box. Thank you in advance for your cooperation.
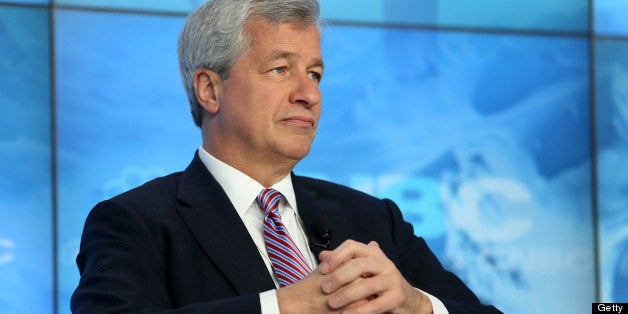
[277,240,432,314]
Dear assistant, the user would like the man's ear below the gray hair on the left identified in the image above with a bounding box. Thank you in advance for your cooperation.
[194,68,222,113]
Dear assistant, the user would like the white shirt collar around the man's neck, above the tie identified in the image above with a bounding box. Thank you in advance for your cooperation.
[198,146,297,216]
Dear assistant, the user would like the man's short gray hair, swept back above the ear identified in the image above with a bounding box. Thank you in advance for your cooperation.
[178,0,320,127]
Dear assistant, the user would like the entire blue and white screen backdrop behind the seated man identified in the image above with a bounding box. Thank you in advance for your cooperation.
[0,0,628,313]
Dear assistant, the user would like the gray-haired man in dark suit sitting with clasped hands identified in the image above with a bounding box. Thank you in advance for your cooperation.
[71,0,499,313]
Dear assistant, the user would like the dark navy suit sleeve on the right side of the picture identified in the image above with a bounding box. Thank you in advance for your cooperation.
[384,200,501,314]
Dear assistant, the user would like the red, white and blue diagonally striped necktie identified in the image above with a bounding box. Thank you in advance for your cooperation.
[257,189,312,287]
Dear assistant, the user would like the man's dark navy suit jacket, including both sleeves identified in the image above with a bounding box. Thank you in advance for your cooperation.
[71,155,499,314]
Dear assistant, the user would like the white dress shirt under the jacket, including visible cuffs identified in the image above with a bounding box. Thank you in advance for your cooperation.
[198,146,448,314]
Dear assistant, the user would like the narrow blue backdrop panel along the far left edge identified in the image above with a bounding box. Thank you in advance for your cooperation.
[0,6,54,313]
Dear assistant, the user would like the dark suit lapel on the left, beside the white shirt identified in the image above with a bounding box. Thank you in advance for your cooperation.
[178,154,275,294]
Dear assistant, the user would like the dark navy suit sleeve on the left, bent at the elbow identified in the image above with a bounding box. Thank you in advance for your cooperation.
[71,201,261,313]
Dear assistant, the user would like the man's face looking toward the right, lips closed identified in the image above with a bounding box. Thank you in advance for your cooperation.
[214,20,323,175]
